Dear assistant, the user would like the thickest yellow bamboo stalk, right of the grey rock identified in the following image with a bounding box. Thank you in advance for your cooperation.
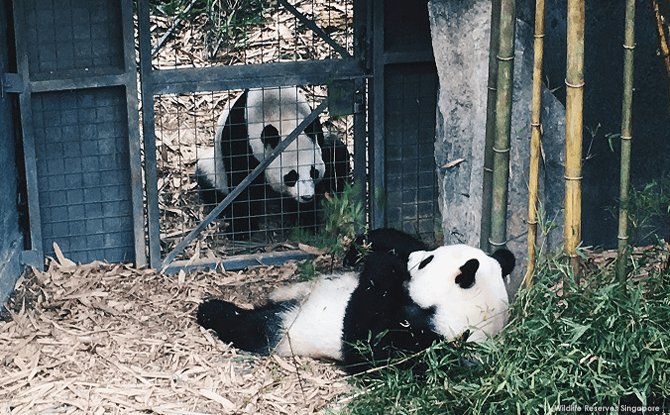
[564,0,585,281]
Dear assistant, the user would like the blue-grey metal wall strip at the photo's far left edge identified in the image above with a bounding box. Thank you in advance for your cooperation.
[0,0,23,304]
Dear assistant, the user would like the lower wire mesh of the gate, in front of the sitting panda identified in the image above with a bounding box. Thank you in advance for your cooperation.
[154,86,353,258]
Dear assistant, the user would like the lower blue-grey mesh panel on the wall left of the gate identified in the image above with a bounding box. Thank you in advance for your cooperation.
[32,88,134,263]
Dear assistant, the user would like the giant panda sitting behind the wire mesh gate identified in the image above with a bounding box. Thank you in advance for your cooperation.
[195,86,349,237]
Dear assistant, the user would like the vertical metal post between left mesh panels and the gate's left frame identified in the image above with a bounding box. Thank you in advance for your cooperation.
[121,0,147,267]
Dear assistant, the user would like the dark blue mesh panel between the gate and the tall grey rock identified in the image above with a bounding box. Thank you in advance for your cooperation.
[370,0,441,243]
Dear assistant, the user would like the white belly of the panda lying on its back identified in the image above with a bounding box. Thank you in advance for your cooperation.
[275,272,358,360]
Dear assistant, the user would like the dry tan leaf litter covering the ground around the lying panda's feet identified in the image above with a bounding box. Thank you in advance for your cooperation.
[0,249,351,415]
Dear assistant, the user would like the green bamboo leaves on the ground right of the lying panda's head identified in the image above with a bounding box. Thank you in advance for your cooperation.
[344,255,670,414]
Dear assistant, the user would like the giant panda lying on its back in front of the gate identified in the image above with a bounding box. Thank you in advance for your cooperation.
[197,239,515,374]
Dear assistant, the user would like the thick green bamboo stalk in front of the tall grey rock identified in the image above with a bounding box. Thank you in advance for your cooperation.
[489,0,516,249]
